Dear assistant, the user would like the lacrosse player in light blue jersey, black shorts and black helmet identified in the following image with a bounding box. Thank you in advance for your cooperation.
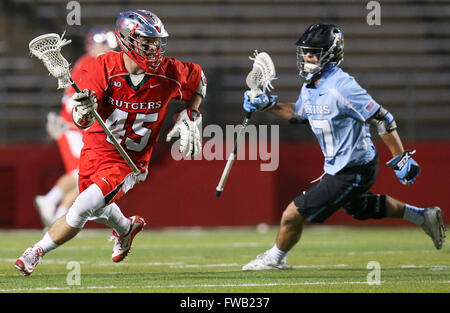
[242,24,445,270]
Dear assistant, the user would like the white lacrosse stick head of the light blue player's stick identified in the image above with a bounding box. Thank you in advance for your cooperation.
[246,50,276,99]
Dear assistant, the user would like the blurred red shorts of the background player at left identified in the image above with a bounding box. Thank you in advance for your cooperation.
[57,129,83,173]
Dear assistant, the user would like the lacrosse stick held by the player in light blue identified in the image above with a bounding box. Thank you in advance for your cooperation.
[216,50,276,197]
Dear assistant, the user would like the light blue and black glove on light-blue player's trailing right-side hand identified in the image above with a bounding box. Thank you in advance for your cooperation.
[386,150,420,185]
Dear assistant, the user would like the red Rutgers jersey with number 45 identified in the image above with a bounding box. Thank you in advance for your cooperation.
[78,52,202,168]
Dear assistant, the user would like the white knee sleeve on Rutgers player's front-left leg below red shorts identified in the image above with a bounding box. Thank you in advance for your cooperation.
[66,184,105,228]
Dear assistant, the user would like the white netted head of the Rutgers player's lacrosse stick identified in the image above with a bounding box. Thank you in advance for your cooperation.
[28,34,72,89]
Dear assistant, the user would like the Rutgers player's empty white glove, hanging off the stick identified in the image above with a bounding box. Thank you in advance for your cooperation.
[166,108,202,156]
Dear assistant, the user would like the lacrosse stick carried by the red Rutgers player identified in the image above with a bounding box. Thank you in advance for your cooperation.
[29,34,141,175]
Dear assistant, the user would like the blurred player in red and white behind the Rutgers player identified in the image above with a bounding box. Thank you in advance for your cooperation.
[34,28,117,228]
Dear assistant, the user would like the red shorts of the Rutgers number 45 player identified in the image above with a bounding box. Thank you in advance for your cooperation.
[78,149,136,205]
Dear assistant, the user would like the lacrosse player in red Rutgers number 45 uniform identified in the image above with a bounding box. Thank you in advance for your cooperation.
[15,10,206,275]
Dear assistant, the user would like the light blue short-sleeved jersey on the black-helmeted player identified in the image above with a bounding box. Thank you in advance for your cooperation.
[295,67,380,175]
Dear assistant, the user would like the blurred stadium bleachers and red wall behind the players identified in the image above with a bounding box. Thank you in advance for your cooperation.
[0,0,450,228]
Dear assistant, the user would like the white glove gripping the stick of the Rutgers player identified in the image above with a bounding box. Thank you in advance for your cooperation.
[72,89,97,128]
